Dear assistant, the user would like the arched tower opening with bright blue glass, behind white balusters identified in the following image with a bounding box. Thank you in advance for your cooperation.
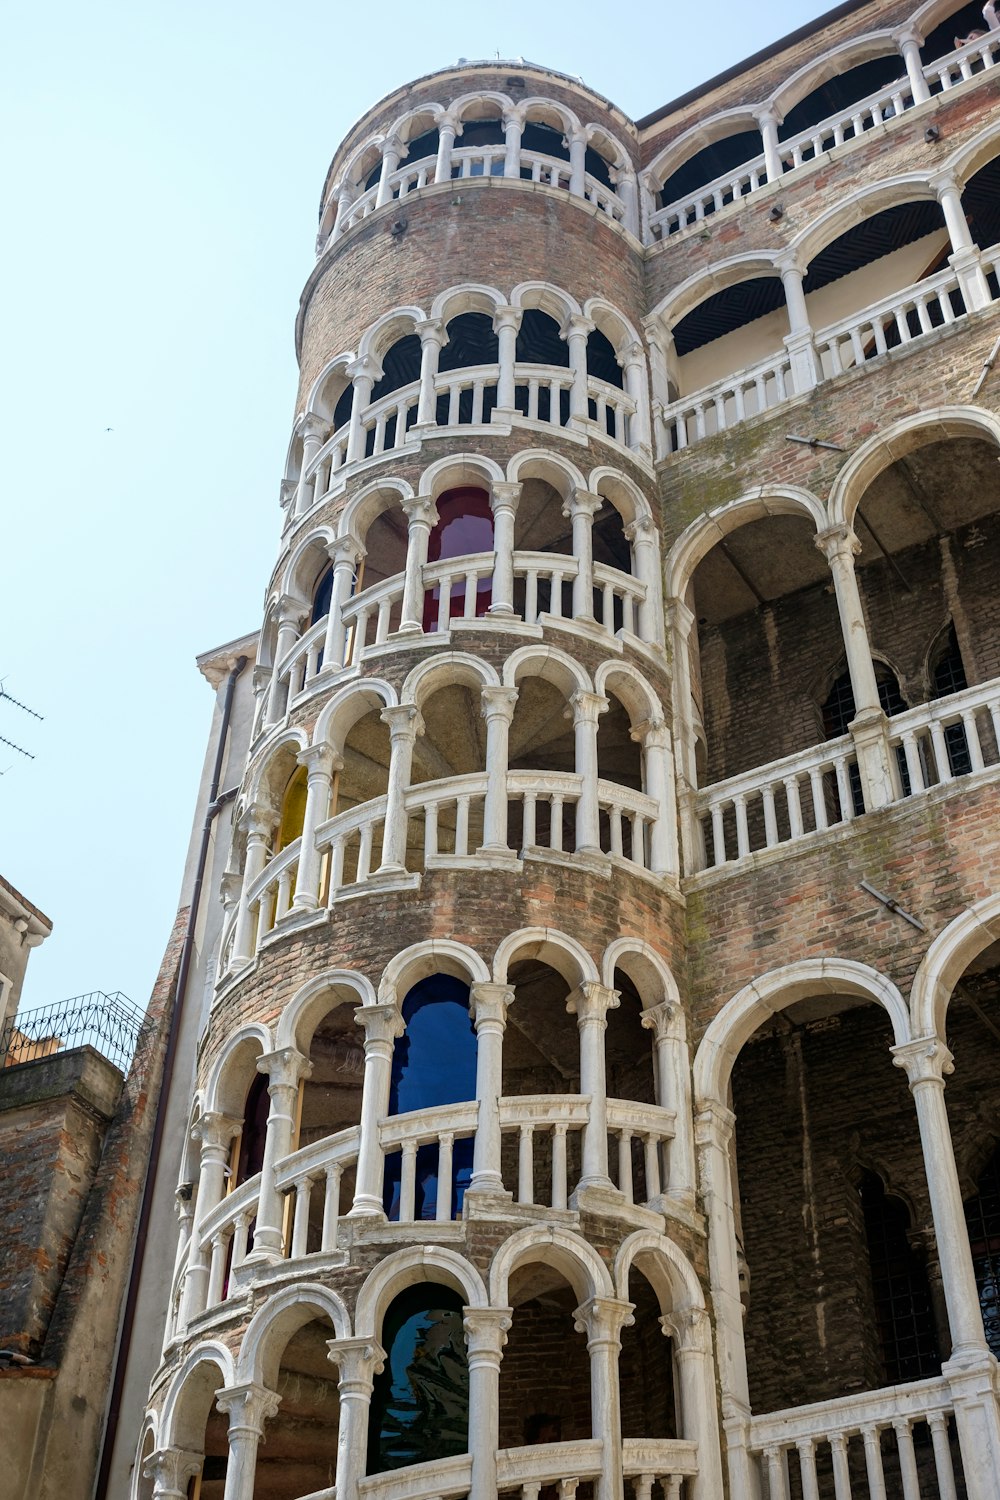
[384,974,475,1224]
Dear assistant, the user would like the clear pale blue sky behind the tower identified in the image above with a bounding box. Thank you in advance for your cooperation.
[0,0,828,1007]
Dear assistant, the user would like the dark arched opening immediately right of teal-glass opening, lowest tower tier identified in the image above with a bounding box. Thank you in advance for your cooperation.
[499,1262,592,1446]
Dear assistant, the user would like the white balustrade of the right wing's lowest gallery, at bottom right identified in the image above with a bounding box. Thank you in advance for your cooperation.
[750,1379,964,1500]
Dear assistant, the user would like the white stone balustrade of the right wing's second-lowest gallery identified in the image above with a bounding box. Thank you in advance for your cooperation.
[694,678,1000,866]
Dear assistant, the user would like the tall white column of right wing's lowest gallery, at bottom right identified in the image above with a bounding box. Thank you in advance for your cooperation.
[892,1037,1000,1500]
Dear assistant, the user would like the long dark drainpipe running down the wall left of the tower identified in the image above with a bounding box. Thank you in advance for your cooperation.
[94,657,247,1500]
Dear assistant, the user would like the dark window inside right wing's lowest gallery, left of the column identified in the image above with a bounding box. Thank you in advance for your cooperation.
[861,1172,942,1385]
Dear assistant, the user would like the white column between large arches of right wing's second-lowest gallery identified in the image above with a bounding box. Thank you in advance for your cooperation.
[816,527,897,810]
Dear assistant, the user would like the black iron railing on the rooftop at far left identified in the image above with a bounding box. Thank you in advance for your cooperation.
[0,990,151,1074]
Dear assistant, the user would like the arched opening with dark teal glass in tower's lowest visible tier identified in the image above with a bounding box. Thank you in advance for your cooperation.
[367,1283,469,1475]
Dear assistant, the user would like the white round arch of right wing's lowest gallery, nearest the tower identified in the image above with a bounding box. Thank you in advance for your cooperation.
[694,959,910,1109]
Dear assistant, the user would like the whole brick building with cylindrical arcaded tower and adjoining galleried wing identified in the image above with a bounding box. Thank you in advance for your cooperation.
[107,0,1000,1500]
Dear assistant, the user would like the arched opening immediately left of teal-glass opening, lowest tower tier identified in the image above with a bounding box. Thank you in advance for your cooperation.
[253,1317,340,1500]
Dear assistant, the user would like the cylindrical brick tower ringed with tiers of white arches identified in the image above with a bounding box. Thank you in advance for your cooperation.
[141,63,720,1500]
